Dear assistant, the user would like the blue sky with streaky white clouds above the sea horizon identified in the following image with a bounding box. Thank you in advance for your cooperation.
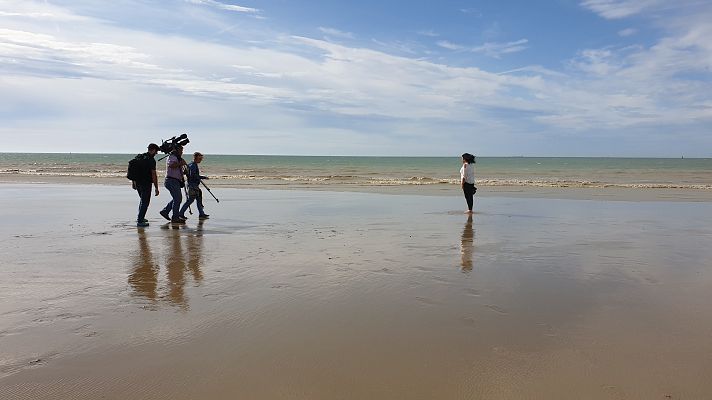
[0,0,712,157]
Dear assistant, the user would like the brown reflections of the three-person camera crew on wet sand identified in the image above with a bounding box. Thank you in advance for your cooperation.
[128,221,204,310]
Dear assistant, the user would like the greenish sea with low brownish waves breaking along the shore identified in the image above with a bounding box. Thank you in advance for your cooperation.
[0,153,712,190]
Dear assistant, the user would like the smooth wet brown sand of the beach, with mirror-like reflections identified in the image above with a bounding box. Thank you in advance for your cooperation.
[0,184,712,399]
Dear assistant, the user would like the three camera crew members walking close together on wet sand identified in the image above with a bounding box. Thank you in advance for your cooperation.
[132,143,210,227]
